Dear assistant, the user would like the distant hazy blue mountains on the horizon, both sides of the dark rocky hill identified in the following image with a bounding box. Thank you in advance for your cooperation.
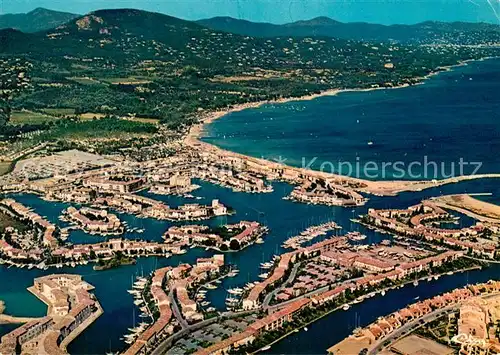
[0,8,500,44]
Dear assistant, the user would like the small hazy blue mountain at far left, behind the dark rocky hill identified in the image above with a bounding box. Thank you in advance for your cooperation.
[0,8,80,32]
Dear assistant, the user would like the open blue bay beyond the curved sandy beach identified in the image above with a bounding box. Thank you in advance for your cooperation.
[203,59,500,180]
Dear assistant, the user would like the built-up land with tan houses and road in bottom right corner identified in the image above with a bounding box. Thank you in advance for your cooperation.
[328,280,500,355]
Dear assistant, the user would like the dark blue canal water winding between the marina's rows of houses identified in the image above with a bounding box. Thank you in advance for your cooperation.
[0,58,500,354]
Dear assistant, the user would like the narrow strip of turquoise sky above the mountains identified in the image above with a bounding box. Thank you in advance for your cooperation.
[0,0,500,24]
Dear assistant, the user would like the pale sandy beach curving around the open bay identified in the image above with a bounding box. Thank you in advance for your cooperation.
[182,57,500,196]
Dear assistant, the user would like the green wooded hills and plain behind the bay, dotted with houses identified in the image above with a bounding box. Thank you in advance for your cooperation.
[0,9,498,133]
